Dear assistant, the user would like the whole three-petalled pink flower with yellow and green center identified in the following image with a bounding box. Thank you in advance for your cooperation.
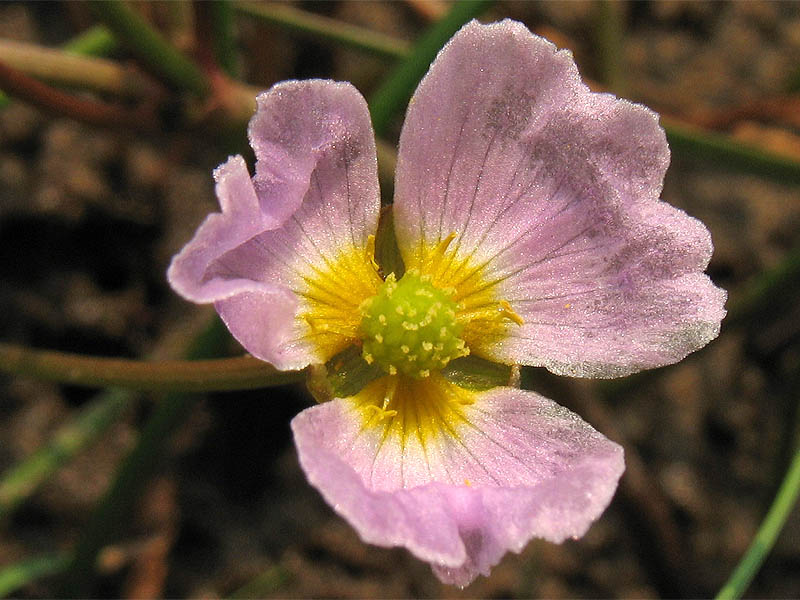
[169,20,725,585]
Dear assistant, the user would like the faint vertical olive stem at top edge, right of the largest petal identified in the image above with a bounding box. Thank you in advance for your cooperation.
[595,0,626,96]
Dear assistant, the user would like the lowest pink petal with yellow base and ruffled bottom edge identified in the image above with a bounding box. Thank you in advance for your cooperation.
[292,378,624,585]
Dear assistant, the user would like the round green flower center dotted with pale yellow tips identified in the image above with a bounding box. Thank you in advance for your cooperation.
[361,270,469,379]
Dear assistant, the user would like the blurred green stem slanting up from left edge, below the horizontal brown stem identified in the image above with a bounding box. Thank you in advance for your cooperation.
[0,390,131,520]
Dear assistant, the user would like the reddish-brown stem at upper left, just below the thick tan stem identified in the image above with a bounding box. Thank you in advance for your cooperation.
[0,61,155,129]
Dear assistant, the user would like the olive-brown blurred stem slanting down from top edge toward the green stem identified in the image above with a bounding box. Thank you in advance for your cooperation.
[234,2,411,59]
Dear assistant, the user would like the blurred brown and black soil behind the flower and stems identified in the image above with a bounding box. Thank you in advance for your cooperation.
[0,1,800,598]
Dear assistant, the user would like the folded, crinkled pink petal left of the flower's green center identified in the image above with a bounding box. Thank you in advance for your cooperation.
[169,80,380,369]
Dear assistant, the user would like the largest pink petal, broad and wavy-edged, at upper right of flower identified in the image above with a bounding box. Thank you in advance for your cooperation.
[394,21,725,377]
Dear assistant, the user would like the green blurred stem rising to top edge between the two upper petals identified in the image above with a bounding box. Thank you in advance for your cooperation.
[369,0,492,136]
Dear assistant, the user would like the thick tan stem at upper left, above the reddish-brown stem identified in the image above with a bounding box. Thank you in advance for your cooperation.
[0,40,160,98]
